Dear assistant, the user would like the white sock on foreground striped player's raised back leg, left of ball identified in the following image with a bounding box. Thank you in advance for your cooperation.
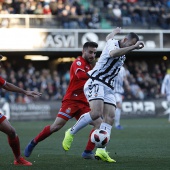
[70,112,93,135]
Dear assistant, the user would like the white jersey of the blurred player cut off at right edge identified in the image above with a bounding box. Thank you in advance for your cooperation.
[161,74,170,96]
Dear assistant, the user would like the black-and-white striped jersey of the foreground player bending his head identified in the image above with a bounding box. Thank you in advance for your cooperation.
[88,39,126,89]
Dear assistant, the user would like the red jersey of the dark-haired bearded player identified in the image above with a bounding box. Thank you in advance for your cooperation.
[63,57,92,102]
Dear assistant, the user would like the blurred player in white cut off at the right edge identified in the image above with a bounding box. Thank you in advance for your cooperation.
[161,69,170,122]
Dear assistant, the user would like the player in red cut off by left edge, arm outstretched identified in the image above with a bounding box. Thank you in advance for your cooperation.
[0,55,41,166]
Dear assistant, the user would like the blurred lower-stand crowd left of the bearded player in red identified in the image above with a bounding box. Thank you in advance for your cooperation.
[0,62,69,103]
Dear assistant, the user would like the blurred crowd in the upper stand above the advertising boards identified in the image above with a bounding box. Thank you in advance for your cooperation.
[0,0,170,29]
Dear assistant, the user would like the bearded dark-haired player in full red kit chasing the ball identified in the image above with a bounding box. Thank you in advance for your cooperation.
[25,42,102,158]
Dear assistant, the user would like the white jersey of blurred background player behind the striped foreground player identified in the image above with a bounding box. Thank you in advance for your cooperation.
[114,67,126,94]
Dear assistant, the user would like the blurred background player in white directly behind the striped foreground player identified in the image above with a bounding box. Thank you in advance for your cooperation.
[114,67,130,130]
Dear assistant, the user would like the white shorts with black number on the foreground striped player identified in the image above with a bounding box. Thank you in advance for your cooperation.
[84,79,116,107]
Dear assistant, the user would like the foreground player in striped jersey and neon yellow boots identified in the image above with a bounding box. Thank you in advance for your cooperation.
[63,27,144,162]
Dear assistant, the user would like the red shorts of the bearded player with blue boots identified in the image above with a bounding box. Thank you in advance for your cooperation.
[57,100,90,120]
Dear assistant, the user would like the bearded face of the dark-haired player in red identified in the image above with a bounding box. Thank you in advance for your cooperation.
[83,47,97,63]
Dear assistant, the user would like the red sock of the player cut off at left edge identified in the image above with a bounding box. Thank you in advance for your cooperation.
[8,136,21,159]
